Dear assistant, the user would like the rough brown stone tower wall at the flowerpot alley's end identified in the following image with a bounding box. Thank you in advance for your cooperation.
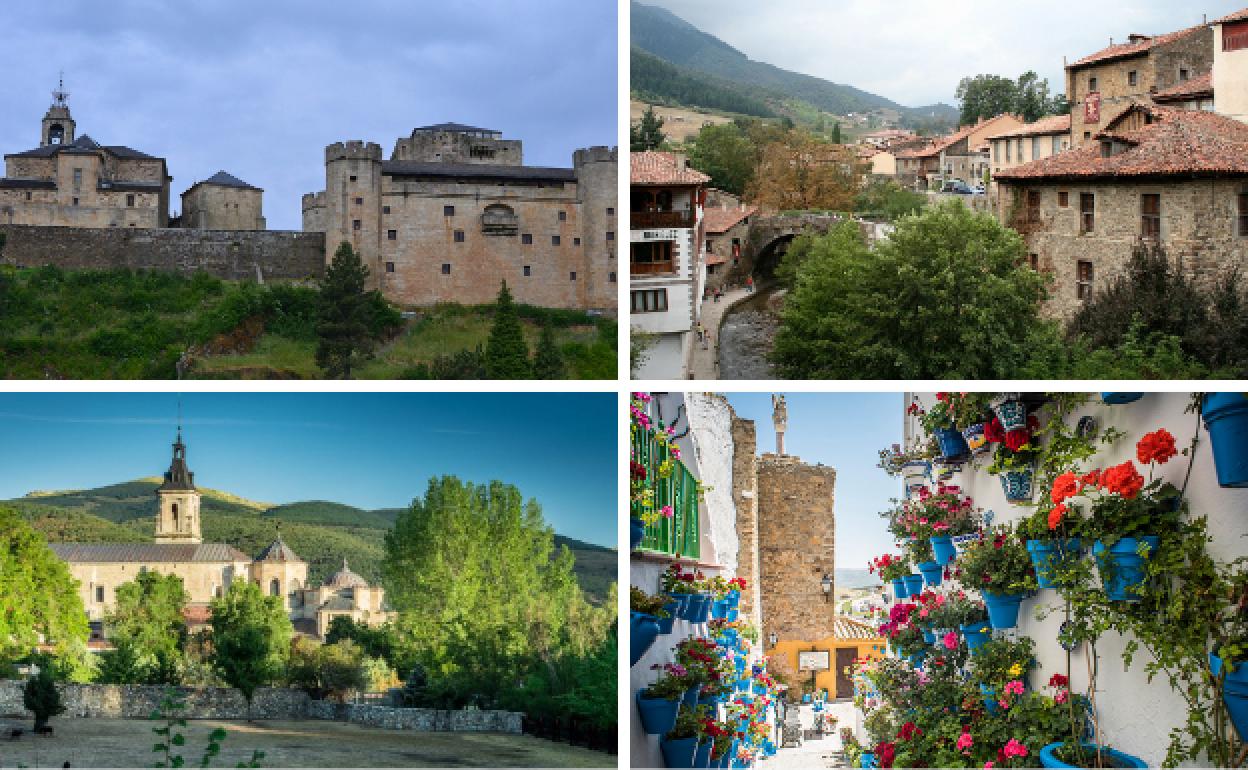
[758,454,836,639]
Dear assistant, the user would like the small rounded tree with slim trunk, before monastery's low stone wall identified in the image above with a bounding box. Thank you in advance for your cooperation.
[212,580,293,721]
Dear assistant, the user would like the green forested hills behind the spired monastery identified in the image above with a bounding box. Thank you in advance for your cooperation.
[0,478,617,602]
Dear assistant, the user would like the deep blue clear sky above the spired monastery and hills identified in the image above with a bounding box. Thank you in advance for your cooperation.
[0,393,618,547]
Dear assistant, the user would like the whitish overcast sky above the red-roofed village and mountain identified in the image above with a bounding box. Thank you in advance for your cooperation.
[644,0,1246,106]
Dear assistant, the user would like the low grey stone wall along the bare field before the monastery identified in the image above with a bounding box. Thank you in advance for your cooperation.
[0,679,524,735]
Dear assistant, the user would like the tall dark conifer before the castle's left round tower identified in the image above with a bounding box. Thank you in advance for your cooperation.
[316,241,373,379]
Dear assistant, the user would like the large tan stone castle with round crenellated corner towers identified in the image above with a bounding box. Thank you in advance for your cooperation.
[303,124,618,313]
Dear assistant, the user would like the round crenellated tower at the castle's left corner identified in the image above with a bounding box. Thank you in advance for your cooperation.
[323,140,383,288]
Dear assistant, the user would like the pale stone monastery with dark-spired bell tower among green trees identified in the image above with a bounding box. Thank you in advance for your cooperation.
[50,428,393,639]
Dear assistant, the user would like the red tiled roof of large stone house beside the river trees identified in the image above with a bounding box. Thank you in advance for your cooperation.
[997,105,1248,182]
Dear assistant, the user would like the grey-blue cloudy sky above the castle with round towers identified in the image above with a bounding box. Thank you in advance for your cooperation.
[0,0,618,230]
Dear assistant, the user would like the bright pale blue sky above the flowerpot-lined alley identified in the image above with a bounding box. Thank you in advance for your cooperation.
[728,393,902,569]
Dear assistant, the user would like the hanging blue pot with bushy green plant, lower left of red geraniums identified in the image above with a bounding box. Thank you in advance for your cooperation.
[957,525,1036,629]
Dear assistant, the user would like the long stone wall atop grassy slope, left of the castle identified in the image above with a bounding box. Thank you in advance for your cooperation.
[0,225,324,281]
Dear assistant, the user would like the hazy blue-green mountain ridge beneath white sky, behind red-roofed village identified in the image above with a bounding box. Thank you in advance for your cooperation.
[630,1,958,124]
